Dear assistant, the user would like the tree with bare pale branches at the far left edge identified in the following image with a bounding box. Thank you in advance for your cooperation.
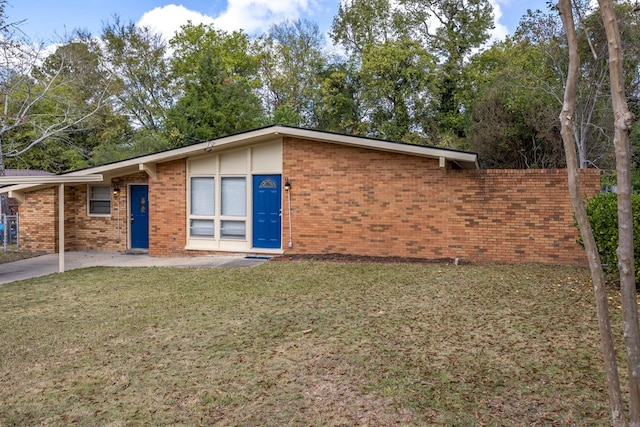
[0,11,110,175]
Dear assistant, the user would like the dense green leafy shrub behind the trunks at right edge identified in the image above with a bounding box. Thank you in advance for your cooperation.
[580,193,640,283]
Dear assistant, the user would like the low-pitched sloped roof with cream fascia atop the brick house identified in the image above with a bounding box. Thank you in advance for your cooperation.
[0,125,479,192]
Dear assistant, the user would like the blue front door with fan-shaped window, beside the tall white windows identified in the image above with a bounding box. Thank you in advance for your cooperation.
[253,175,282,249]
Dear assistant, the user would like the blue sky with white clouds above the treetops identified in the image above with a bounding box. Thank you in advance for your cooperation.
[5,0,547,42]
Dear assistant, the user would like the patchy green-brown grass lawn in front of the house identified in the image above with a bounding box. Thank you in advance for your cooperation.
[0,262,617,426]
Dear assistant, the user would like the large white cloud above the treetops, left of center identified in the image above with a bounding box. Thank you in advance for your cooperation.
[138,0,315,40]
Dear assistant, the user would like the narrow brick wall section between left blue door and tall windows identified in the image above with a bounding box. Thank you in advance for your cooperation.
[149,159,187,256]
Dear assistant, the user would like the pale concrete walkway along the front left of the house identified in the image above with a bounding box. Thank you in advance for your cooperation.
[0,252,268,285]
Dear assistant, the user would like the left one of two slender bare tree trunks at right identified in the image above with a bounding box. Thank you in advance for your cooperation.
[558,0,625,427]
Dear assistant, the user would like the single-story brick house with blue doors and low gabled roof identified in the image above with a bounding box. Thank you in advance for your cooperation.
[0,126,600,264]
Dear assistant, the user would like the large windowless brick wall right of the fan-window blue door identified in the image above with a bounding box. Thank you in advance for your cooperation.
[283,138,600,264]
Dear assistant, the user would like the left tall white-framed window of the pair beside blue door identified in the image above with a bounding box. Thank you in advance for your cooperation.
[189,176,216,237]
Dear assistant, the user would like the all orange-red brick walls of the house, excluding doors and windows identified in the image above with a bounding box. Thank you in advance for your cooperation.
[20,138,599,264]
